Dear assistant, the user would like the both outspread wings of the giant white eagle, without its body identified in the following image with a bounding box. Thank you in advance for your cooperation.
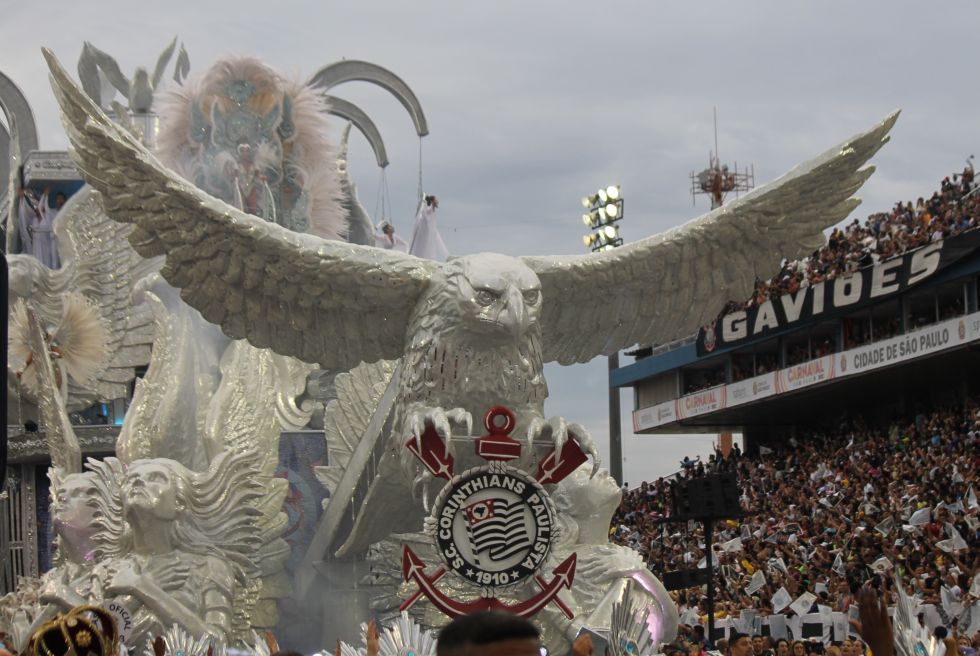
[51,44,898,368]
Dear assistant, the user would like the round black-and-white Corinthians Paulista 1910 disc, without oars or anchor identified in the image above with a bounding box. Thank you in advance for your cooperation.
[432,463,555,587]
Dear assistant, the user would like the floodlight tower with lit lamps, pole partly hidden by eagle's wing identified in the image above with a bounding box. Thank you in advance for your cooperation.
[582,185,623,485]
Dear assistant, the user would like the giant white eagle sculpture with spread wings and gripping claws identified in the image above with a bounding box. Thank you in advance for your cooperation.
[44,50,897,545]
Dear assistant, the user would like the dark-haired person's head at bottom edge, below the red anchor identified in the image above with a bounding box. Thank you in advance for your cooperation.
[436,611,541,656]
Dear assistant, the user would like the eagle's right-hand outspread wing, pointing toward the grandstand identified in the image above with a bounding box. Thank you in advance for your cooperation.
[522,112,898,364]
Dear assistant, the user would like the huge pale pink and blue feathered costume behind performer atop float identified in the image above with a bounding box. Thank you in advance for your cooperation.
[155,57,347,239]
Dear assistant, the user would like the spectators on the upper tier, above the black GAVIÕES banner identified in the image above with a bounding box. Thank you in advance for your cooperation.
[722,165,980,314]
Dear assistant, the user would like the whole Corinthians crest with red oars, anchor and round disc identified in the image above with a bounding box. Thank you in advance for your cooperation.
[401,406,587,618]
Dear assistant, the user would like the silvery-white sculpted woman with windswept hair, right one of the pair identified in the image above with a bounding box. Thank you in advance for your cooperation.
[105,452,260,644]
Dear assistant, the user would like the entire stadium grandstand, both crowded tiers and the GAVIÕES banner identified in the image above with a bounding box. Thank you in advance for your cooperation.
[610,168,980,644]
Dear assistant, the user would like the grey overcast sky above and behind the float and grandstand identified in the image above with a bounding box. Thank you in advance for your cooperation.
[0,0,980,482]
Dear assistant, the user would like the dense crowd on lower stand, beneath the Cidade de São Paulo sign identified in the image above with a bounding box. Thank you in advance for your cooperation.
[610,399,980,629]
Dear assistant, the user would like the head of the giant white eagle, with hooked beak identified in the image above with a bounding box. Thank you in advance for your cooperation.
[452,253,541,338]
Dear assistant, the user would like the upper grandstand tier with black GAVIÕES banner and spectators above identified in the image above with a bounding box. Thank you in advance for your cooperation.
[611,164,980,444]
